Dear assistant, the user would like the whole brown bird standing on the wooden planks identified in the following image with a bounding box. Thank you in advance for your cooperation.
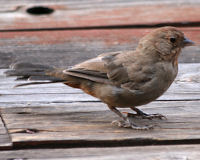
[6,27,194,129]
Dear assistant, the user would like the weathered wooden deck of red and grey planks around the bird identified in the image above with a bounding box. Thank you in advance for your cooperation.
[0,0,200,160]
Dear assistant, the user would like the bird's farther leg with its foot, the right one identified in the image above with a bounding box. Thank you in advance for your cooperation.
[130,107,167,119]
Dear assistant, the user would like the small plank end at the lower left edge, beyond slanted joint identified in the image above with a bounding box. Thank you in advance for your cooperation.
[0,114,12,149]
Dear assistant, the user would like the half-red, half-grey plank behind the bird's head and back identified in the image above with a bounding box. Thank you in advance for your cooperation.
[0,28,200,68]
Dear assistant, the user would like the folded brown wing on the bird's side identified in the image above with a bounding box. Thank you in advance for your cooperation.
[63,51,154,90]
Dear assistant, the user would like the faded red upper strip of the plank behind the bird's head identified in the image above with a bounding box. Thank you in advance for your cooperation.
[0,27,200,46]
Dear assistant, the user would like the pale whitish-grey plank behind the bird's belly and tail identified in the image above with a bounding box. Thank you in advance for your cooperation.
[0,63,200,107]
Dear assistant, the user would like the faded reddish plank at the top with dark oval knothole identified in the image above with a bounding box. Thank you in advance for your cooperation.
[0,0,200,30]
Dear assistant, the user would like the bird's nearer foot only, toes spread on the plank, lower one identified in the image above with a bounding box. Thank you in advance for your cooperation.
[112,117,154,130]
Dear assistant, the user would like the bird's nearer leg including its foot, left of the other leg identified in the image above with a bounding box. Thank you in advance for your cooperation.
[108,105,153,130]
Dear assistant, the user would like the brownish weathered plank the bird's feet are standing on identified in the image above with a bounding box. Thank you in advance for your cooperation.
[2,101,200,148]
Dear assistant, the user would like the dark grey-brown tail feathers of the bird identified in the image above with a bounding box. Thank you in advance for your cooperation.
[5,62,64,87]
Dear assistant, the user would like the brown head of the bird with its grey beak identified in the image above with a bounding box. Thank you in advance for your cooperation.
[139,27,194,60]
